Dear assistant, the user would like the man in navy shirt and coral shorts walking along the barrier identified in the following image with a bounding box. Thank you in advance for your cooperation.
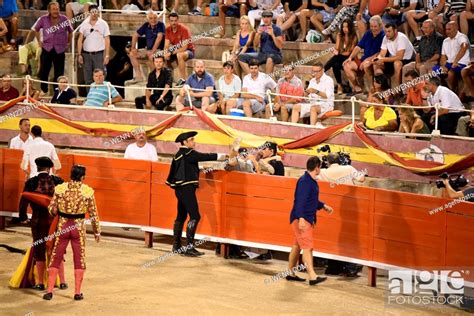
[286,156,333,285]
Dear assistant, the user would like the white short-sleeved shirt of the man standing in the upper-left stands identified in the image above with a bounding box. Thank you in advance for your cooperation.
[79,18,110,52]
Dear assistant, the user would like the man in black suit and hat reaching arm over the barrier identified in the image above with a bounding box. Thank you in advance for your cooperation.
[166,131,226,257]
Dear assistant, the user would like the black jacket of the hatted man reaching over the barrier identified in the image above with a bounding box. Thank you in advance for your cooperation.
[166,147,218,189]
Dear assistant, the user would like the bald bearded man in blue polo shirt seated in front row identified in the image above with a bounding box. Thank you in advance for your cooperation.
[176,60,217,113]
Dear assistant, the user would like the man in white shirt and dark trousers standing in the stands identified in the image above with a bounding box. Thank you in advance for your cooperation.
[77,4,110,84]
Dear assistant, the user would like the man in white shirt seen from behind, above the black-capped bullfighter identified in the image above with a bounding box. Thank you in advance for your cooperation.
[21,125,61,178]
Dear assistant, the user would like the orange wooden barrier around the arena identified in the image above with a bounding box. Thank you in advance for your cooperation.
[0,149,474,285]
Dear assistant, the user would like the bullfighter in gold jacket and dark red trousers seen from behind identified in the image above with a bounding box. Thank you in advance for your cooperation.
[43,165,100,300]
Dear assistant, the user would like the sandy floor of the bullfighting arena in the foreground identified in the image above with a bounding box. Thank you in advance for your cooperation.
[0,227,467,316]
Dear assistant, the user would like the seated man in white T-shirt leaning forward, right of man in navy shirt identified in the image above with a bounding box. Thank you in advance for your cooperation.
[374,23,415,86]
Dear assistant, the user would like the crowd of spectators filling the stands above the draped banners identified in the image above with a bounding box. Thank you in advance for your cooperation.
[0,0,474,135]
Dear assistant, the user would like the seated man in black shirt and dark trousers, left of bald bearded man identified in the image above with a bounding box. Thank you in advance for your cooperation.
[135,56,173,111]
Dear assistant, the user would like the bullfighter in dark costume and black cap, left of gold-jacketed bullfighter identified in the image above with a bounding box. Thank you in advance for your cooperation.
[19,157,67,291]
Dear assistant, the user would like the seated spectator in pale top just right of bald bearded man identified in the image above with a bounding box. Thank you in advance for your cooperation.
[217,61,242,115]
